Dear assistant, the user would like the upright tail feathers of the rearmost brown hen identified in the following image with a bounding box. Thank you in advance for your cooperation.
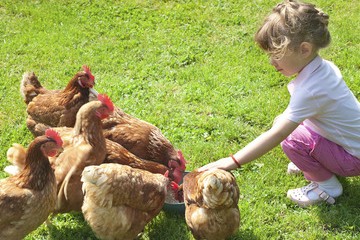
[20,72,43,104]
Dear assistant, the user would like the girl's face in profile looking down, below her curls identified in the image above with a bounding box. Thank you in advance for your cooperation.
[270,51,308,77]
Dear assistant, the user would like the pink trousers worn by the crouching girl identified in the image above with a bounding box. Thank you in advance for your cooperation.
[281,125,360,182]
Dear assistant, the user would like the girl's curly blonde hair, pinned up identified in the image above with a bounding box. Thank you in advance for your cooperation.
[255,0,331,59]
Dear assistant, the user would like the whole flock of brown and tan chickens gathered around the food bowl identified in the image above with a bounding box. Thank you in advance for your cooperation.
[0,66,240,240]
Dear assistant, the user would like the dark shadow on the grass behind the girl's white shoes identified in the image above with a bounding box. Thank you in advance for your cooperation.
[318,177,360,232]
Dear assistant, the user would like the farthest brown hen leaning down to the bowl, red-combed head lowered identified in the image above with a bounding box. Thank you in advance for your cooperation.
[103,107,186,183]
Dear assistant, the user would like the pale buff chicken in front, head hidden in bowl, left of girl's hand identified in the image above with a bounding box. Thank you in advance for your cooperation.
[81,163,169,240]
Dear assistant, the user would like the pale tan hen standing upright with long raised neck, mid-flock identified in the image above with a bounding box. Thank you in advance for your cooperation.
[49,94,114,213]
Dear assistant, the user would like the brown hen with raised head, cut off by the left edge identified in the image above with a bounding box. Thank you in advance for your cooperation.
[0,130,62,240]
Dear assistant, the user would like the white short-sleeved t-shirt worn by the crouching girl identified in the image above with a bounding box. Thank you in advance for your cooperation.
[284,56,360,158]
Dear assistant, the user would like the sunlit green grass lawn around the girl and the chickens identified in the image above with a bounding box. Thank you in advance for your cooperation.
[0,0,360,240]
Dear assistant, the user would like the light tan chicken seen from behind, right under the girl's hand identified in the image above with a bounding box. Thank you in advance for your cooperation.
[183,169,240,240]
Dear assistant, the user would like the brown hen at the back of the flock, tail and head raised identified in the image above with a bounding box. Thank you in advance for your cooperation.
[20,66,97,136]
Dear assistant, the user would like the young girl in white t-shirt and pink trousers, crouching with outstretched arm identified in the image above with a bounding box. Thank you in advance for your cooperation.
[199,0,360,207]
